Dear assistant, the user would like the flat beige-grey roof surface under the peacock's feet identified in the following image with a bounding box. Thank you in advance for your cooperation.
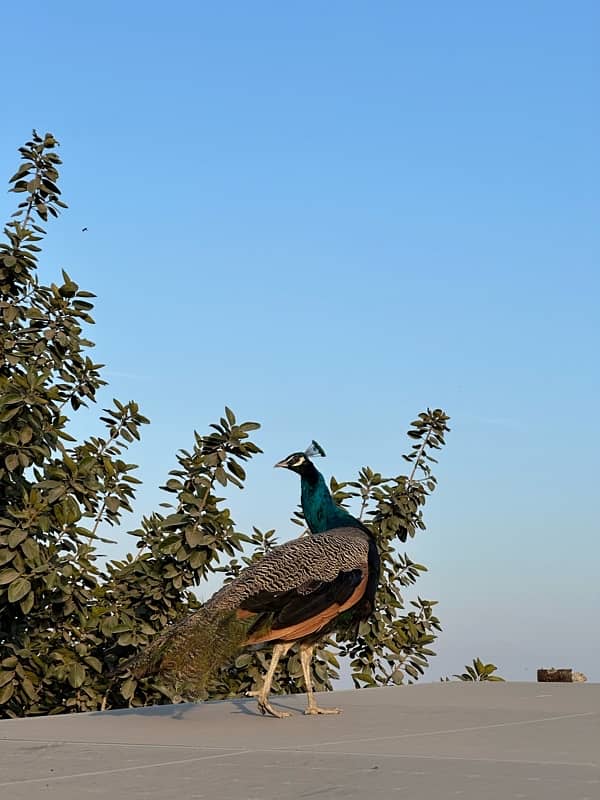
[0,682,600,800]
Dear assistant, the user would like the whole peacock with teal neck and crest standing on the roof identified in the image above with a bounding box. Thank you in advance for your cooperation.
[126,441,380,717]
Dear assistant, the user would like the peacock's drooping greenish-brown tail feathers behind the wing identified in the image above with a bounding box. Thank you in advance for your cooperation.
[125,607,249,696]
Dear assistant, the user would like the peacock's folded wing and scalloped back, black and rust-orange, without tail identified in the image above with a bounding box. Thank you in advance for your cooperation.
[208,528,369,644]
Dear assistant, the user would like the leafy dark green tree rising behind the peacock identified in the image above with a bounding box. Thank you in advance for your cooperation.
[0,131,448,717]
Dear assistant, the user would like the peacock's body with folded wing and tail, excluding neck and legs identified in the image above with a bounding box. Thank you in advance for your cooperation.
[126,528,369,692]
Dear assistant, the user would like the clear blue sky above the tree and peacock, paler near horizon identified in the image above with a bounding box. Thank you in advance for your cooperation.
[0,0,600,680]
